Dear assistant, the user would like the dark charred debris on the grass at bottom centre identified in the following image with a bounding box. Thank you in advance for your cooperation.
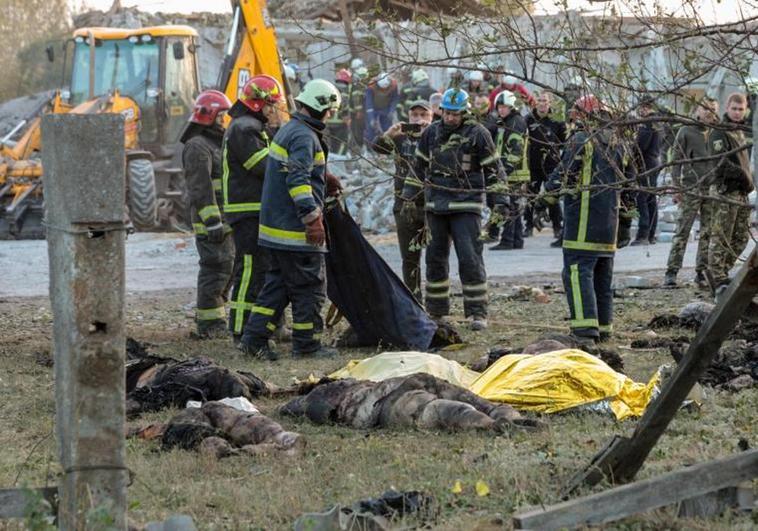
[295,490,438,531]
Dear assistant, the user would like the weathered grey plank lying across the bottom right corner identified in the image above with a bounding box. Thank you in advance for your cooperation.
[513,450,758,530]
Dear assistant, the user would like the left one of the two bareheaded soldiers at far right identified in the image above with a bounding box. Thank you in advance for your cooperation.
[663,99,718,288]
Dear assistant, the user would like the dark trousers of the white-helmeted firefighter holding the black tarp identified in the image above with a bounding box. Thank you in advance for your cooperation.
[242,249,326,354]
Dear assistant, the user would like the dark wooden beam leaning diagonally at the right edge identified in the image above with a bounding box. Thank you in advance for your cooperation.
[564,249,758,497]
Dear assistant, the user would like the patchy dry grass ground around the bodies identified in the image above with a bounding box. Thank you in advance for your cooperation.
[0,277,758,530]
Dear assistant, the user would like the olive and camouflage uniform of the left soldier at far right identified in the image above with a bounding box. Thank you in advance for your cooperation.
[667,125,713,275]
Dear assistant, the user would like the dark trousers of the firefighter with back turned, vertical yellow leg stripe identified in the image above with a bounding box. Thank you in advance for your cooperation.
[563,249,613,338]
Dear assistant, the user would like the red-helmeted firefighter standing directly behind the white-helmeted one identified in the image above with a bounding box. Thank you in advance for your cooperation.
[222,75,283,343]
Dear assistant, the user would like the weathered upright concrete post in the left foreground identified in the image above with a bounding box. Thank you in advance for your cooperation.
[42,114,128,530]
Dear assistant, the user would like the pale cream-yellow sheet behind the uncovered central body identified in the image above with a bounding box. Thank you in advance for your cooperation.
[329,352,480,389]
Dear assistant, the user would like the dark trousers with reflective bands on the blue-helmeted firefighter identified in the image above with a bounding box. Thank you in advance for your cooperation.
[426,212,487,317]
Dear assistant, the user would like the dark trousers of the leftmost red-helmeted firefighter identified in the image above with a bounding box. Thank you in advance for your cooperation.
[195,234,234,333]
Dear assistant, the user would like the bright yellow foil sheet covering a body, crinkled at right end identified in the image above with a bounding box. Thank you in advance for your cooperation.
[469,349,659,420]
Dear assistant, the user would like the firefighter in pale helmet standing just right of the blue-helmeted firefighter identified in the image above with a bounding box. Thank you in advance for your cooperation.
[487,90,529,251]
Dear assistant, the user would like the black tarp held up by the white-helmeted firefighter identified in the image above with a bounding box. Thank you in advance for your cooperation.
[325,202,437,351]
